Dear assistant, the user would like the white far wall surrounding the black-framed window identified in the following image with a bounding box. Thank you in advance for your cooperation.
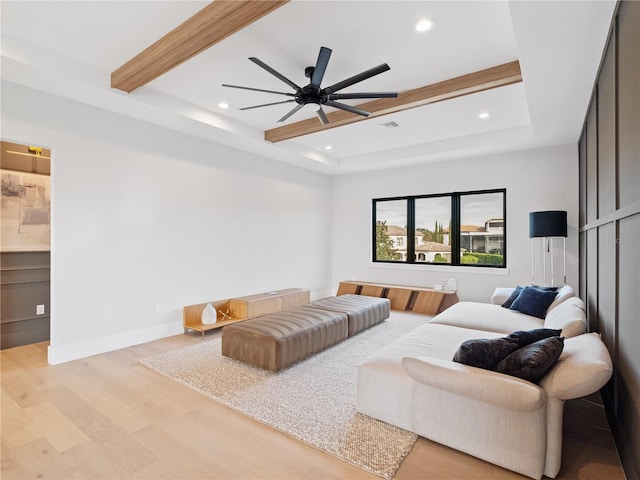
[332,145,578,302]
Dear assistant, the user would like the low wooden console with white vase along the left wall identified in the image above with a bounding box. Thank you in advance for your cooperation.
[182,288,311,337]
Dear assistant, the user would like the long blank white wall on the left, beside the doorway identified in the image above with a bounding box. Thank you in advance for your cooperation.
[2,82,332,363]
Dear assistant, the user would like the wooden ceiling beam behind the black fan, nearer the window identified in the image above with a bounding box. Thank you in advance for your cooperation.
[264,60,522,143]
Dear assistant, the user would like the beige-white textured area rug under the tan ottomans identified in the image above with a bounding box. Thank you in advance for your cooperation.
[141,312,426,479]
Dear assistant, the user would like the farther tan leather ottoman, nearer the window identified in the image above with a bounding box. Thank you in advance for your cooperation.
[309,294,391,337]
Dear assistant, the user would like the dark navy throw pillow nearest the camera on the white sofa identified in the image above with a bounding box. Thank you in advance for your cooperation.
[496,337,564,383]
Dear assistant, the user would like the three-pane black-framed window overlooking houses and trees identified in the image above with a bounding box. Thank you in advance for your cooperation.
[373,189,507,267]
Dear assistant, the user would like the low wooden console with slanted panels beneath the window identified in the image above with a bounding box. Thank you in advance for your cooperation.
[337,280,458,315]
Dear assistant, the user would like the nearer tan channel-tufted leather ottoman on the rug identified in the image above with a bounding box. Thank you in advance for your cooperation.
[222,306,348,372]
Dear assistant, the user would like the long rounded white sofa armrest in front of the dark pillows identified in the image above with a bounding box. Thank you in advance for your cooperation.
[402,357,545,412]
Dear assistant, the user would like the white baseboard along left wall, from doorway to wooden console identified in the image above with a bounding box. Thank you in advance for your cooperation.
[48,322,184,365]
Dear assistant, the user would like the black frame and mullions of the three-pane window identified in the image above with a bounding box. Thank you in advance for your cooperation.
[371,188,507,268]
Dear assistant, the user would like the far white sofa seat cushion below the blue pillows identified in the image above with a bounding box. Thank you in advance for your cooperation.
[429,302,554,338]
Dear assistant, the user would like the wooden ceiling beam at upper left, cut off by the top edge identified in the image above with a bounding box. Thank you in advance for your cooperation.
[111,0,289,92]
